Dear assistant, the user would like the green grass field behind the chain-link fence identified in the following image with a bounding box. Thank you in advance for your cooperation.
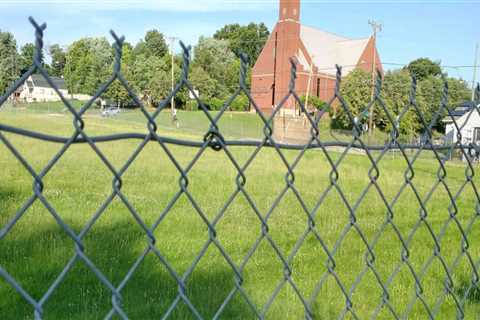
[0,104,480,319]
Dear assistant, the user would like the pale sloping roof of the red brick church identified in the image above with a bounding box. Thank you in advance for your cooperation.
[299,25,370,75]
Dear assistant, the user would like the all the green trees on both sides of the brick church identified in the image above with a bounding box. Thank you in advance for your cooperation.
[0,23,470,128]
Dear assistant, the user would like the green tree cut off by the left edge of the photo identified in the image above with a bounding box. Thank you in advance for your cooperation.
[0,30,20,95]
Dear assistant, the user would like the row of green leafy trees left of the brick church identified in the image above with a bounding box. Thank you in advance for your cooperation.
[0,23,269,108]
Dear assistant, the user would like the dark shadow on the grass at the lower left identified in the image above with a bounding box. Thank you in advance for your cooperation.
[0,222,255,320]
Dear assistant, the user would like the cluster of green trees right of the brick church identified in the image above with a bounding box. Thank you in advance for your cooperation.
[332,58,471,138]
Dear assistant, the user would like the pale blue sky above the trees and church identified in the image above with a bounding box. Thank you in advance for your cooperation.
[0,0,480,82]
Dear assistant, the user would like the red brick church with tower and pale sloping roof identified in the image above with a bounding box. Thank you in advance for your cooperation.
[251,0,383,114]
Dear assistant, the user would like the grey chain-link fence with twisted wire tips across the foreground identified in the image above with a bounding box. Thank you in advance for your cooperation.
[0,18,480,319]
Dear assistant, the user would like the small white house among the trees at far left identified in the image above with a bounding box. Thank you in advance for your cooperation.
[18,74,68,102]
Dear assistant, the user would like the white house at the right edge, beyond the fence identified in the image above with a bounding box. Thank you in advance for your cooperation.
[443,101,480,145]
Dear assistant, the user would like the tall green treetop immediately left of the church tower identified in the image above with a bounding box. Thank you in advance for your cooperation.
[213,22,270,64]
